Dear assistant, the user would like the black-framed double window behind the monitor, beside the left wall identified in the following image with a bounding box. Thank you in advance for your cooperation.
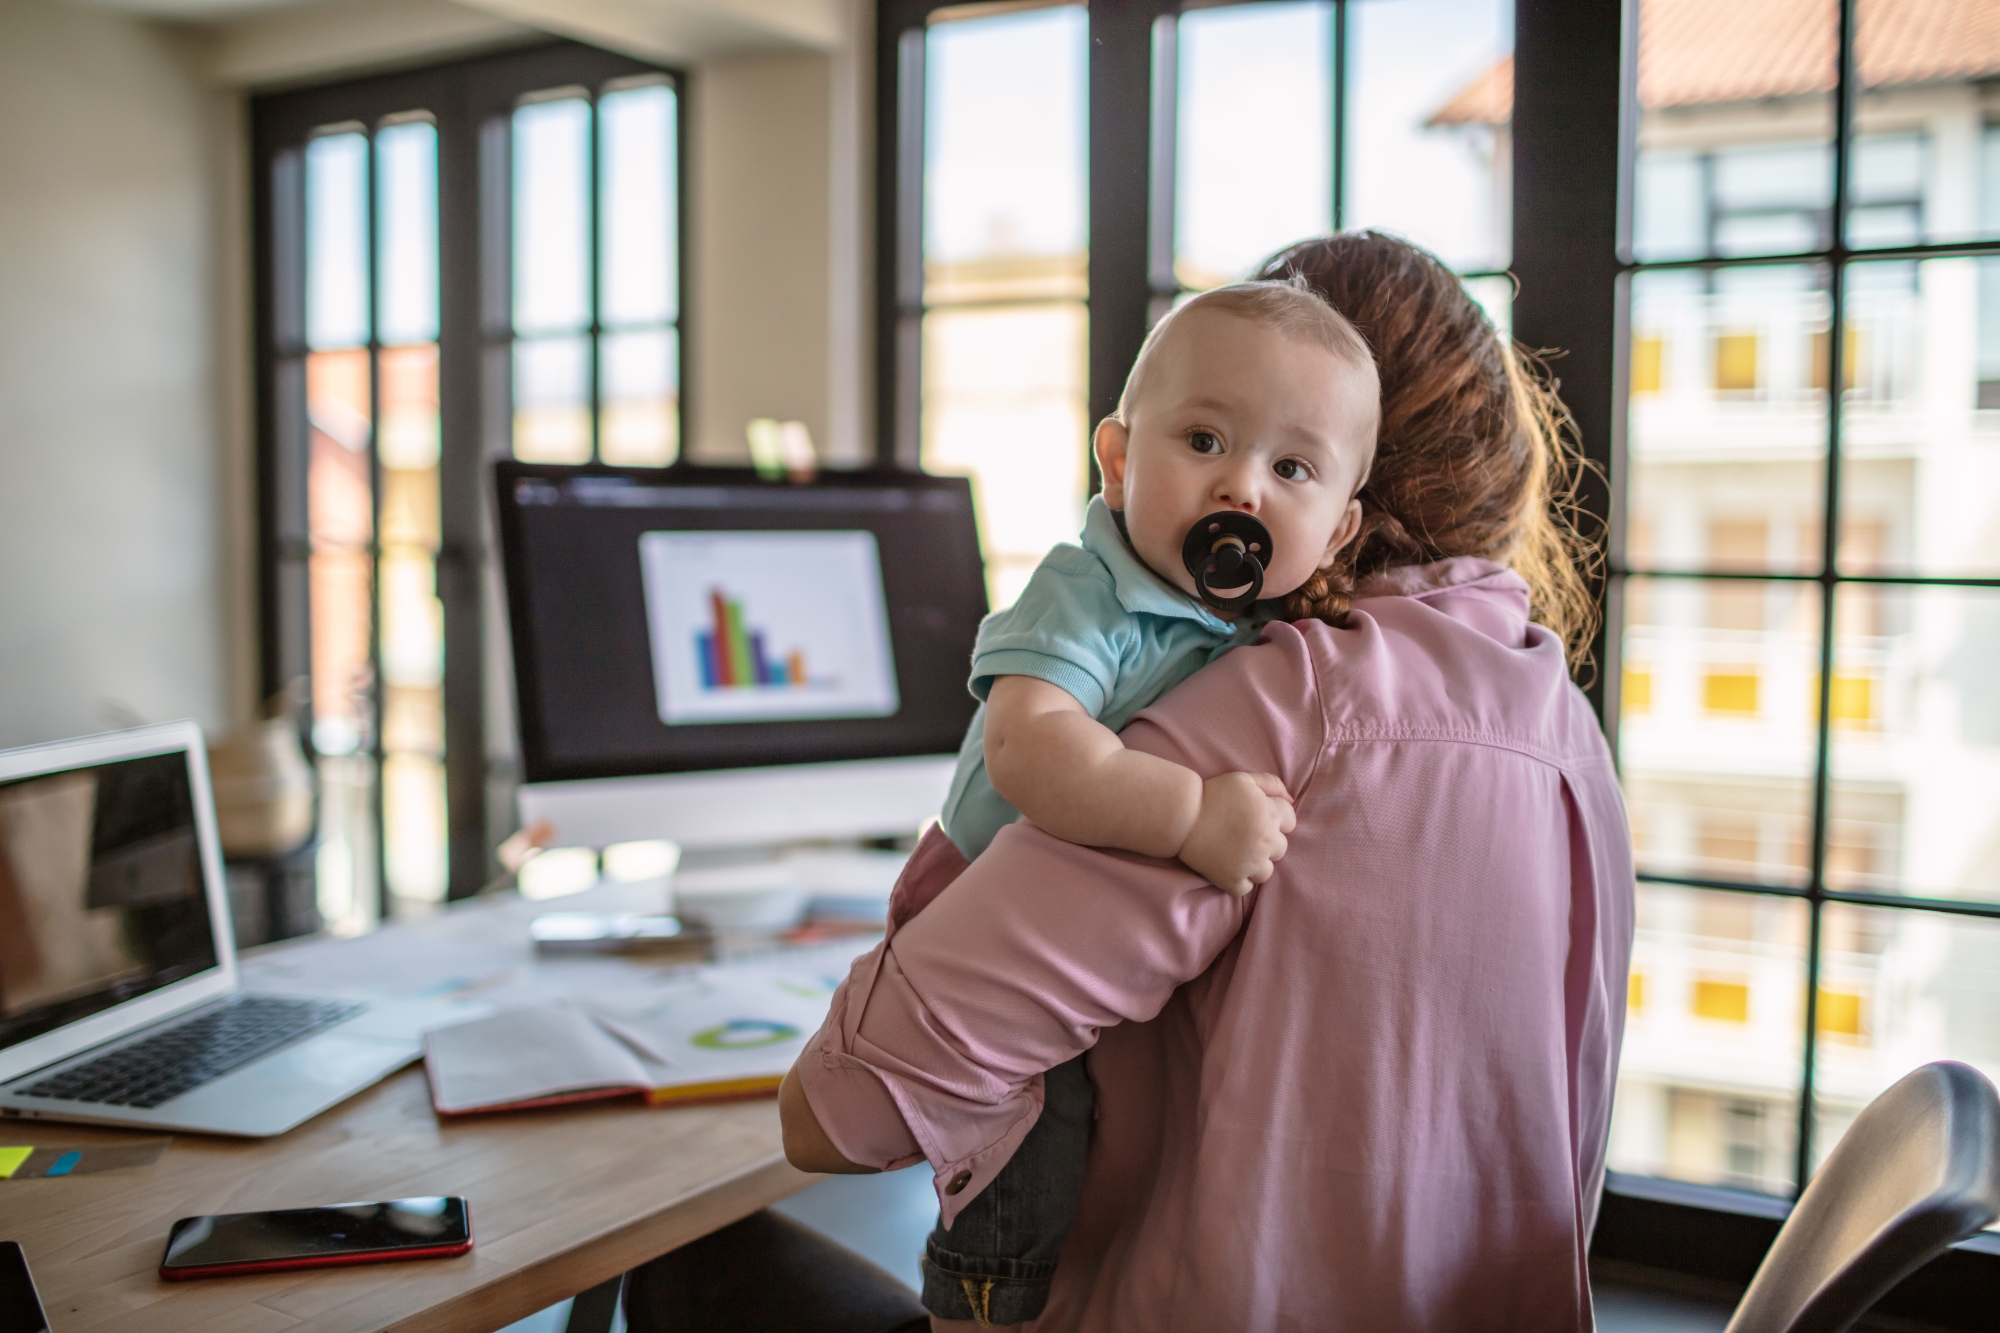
[254,42,680,933]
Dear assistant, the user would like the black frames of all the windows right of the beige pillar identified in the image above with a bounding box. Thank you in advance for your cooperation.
[874,0,2000,1304]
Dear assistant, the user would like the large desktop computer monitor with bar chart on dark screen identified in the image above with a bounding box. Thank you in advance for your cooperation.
[496,462,986,847]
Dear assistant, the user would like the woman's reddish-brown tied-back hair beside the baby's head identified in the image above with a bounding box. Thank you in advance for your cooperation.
[1256,232,1600,667]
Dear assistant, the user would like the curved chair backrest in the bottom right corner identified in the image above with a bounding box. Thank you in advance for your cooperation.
[1728,1061,2000,1333]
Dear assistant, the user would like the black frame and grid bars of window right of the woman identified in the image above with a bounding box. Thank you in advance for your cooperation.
[1592,0,2000,1296]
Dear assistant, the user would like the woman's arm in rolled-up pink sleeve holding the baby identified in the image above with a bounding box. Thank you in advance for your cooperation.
[794,624,1324,1215]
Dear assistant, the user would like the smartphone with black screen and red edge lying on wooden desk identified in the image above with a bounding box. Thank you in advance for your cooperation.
[160,1197,472,1281]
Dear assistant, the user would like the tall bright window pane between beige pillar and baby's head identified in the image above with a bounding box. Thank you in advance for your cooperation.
[920,4,1090,606]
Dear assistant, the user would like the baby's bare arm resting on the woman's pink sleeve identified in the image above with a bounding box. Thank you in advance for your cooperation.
[986,677,1294,895]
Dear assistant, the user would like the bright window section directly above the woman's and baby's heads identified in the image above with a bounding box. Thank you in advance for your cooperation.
[1154,0,1514,300]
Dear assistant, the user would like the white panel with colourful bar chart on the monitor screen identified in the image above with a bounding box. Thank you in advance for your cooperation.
[638,532,898,727]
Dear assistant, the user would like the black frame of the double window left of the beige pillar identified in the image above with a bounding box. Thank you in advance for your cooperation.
[250,40,690,904]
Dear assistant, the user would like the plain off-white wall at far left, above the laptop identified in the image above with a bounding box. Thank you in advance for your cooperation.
[0,0,234,747]
